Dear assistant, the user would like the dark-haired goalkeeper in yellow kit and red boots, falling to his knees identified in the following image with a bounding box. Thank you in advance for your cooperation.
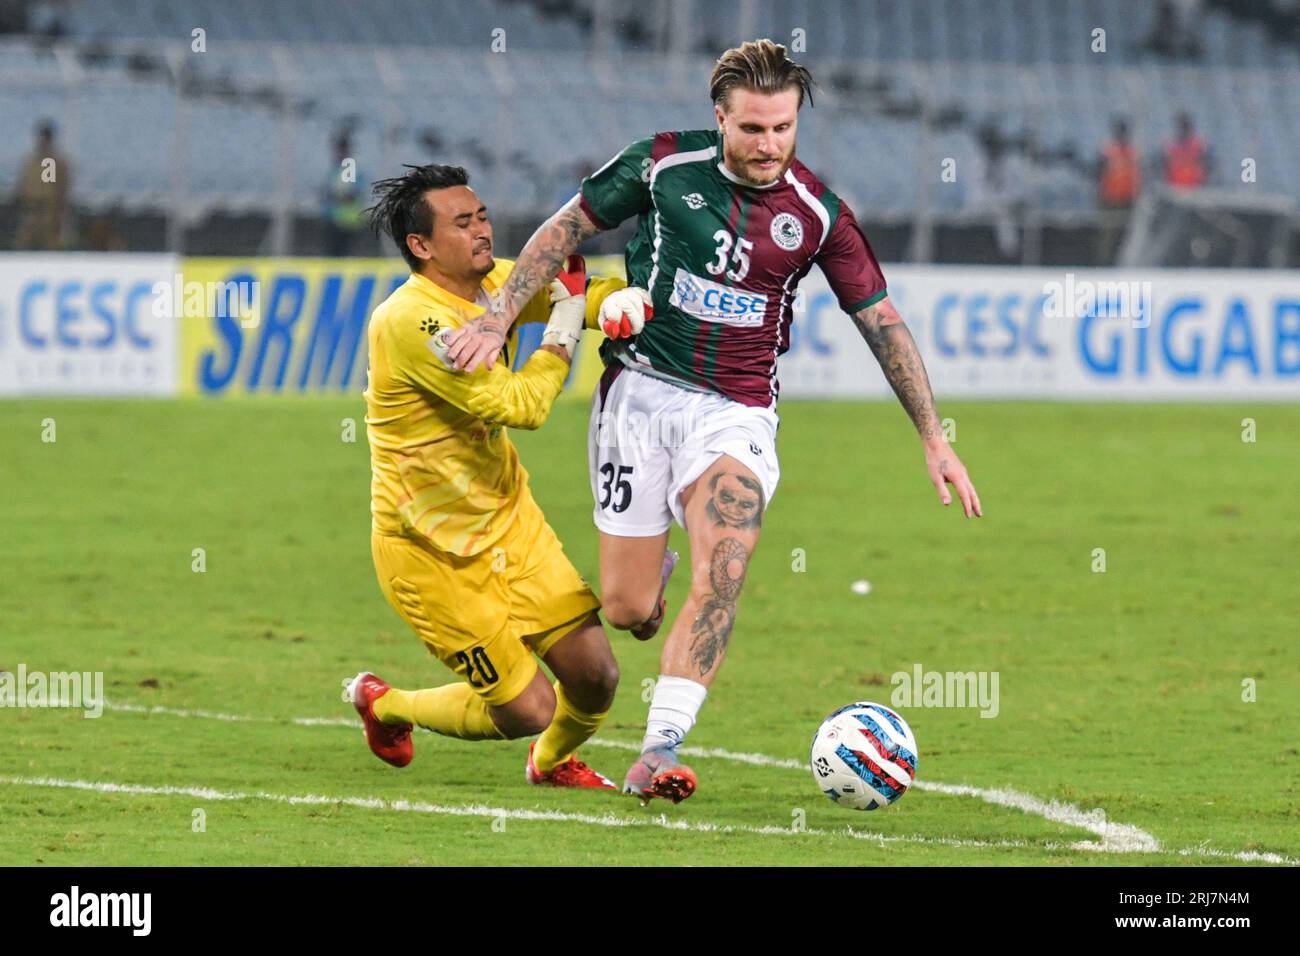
[345,165,624,790]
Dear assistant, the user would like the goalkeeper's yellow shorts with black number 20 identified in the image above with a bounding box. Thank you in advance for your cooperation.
[371,486,601,706]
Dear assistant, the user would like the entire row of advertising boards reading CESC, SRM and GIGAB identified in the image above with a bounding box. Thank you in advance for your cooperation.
[0,254,1300,401]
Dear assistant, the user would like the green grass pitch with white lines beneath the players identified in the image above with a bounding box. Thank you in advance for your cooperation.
[0,398,1300,865]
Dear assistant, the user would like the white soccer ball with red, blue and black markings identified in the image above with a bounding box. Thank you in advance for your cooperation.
[809,701,917,810]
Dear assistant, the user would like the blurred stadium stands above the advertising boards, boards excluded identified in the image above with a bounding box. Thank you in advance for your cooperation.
[0,0,1300,267]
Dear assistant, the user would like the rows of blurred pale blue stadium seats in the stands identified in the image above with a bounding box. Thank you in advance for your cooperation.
[0,0,1300,216]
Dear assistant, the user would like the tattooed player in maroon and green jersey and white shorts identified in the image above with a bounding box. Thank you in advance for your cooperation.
[449,40,982,803]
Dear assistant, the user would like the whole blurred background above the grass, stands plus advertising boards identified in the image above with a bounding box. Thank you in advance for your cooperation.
[0,0,1300,399]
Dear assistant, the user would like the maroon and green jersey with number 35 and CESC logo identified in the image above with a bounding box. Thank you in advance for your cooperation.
[580,130,885,407]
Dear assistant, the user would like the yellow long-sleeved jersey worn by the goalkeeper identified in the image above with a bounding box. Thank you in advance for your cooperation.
[365,259,625,557]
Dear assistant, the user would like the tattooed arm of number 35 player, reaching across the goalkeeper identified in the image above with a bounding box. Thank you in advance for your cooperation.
[447,196,601,372]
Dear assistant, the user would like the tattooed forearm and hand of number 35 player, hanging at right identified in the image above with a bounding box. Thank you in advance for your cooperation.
[853,295,983,518]
